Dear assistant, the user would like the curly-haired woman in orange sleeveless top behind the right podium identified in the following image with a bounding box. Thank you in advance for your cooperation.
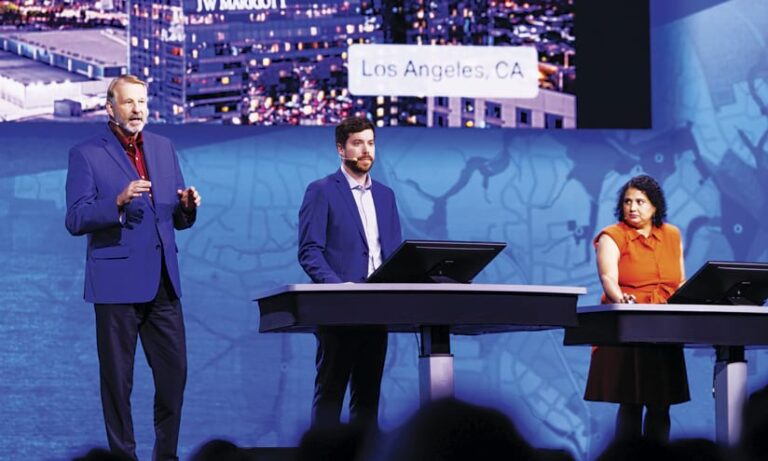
[584,175,690,441]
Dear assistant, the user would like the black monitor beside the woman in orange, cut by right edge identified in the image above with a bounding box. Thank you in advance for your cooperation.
[667,261,768,306]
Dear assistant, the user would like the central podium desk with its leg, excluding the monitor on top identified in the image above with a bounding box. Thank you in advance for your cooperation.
[255,283,586,402]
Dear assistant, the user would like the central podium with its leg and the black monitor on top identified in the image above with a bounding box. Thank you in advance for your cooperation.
[255,241,586,401]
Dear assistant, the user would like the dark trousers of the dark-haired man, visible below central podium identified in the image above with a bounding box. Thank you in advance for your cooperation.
[312,327,387,428]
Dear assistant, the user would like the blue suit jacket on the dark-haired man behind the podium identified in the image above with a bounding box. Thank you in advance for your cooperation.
[299,170,402,283]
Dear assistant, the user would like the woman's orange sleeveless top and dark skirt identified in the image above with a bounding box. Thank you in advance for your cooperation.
[584,222,690,405]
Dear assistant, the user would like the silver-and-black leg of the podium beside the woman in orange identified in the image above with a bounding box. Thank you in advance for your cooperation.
[715,346,747,445]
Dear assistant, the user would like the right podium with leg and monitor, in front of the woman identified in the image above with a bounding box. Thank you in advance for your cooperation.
[564,261,768,443]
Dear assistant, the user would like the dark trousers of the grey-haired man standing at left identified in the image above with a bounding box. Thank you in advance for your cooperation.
[94,267,187,461]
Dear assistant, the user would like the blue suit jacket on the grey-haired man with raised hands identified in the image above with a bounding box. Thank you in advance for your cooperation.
[66,127,195,304]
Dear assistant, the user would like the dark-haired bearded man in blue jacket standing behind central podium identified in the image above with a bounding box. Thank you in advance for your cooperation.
[299,117,402,427]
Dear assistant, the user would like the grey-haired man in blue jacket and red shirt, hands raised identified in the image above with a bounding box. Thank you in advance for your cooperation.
[66,75,200,460]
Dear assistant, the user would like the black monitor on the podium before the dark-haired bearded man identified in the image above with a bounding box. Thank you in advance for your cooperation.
[367,240,507,283]
